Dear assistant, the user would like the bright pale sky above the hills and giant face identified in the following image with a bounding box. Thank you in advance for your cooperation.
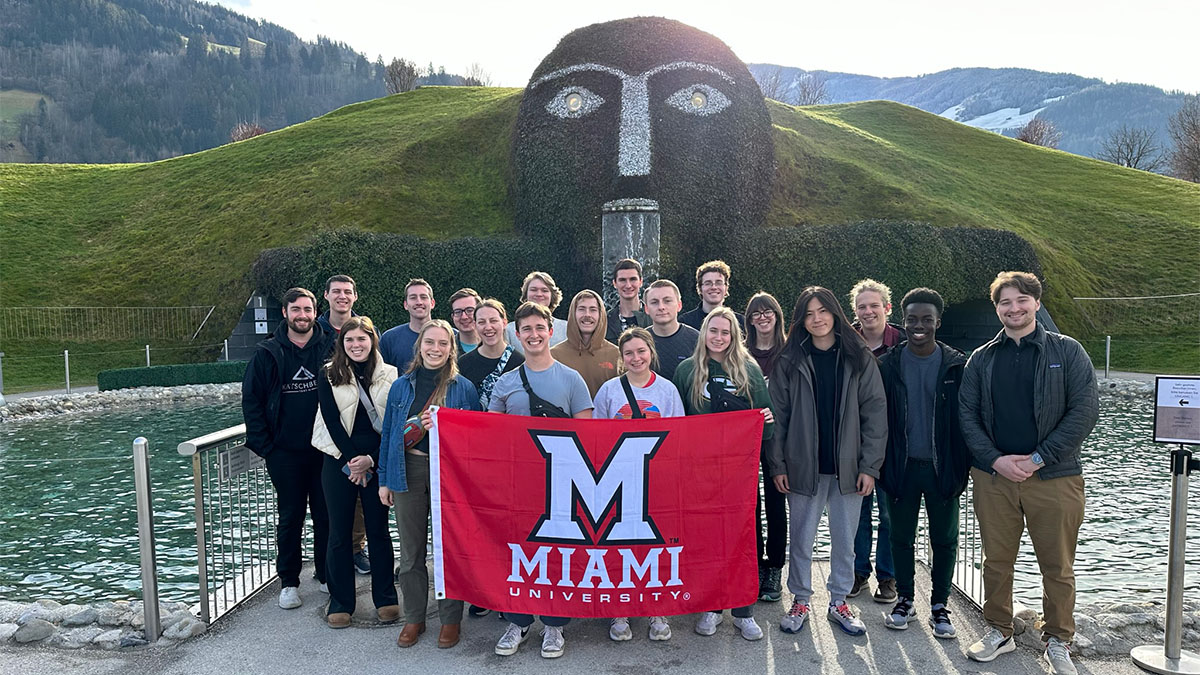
[217,0,1200,92]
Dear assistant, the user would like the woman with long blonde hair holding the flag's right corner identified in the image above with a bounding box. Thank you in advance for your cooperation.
[674,306,775,640]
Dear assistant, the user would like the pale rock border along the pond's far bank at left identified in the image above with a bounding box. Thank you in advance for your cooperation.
[0,382,241,423]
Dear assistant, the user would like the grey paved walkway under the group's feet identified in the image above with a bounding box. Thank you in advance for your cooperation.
[0,562,1141,675]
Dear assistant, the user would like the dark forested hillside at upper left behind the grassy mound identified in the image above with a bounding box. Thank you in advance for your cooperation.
[0,0,472,163]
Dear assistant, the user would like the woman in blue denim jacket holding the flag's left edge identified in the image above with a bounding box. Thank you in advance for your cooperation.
[372,319,479,649]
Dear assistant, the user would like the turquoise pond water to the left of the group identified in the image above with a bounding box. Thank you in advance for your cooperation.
[0,401,241,602]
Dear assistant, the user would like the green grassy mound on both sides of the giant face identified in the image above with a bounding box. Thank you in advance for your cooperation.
[0,88,1200,384]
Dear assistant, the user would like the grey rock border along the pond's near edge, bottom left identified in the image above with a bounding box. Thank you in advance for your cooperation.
[0,599,209,651]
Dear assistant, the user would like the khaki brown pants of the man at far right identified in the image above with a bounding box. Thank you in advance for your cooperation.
[971,467,1084,643]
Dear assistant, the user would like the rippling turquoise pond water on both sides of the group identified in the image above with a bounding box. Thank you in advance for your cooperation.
[0,398,1200,607]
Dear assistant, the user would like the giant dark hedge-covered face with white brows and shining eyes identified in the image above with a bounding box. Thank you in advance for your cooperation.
[512,18,774,276]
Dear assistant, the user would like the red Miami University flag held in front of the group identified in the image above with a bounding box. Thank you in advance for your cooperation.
[430,408,763,617]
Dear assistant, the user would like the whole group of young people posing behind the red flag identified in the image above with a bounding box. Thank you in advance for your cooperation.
[244,259,1096,673]
